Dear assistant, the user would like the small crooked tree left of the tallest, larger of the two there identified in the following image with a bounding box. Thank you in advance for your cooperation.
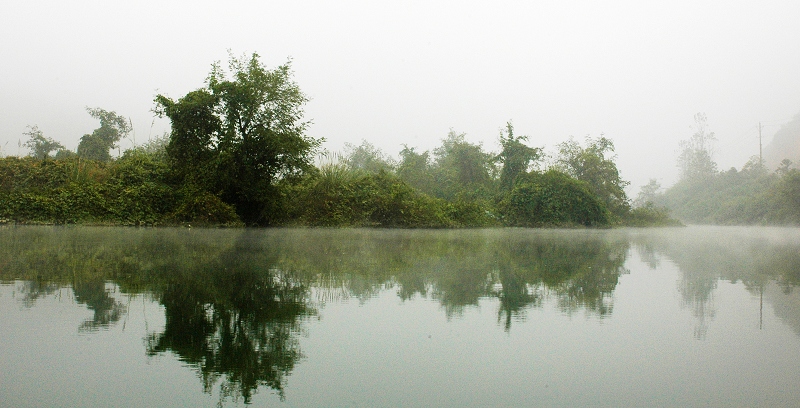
[78,107,132,161]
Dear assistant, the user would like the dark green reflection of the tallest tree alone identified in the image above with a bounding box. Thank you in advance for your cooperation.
[147,234,314,403]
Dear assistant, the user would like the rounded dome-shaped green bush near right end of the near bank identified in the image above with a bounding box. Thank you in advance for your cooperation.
[500,170,609,227]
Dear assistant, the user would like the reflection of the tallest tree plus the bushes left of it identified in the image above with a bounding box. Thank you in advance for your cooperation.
[0,227,315,403]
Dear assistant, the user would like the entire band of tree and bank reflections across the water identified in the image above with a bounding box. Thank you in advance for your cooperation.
[0,227,800,403]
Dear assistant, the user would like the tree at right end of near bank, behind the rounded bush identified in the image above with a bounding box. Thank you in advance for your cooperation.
[558,135,630,217]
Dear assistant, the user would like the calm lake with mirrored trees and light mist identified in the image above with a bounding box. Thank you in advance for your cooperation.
[0,226,800,407]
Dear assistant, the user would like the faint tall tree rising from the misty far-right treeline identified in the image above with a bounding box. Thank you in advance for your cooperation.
[678,113,717,181]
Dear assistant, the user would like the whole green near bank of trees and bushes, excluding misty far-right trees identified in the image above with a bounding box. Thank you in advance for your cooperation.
[0,54,675,228]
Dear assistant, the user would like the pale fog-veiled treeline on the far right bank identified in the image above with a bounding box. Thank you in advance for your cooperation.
[643,114,800,225]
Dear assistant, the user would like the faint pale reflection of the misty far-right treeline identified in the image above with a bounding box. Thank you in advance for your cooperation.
[632,227,800,339]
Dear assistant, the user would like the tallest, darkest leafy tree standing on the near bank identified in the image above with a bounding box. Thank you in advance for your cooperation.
[155,53,321,225]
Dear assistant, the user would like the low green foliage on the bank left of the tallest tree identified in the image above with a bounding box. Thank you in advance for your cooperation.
[0,149,241,225]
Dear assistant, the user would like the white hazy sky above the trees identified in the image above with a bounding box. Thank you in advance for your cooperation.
[0,0,800,191]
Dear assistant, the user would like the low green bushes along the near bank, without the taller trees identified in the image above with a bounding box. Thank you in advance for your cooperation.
[0,138,677,228]
